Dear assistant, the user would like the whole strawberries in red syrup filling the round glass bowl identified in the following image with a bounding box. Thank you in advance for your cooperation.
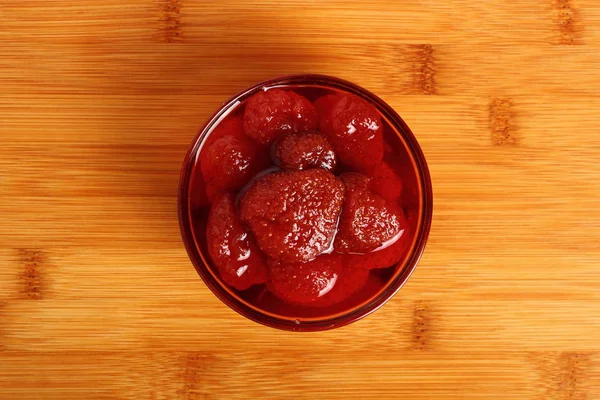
[186,76,424,319]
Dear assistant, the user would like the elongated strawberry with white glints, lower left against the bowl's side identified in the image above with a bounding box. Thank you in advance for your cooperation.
[206,194,267,290]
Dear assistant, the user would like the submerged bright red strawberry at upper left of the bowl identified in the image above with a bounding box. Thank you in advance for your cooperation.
[200,117,269,201]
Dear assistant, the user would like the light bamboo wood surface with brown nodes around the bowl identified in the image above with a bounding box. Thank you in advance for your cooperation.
[0,0,600,400]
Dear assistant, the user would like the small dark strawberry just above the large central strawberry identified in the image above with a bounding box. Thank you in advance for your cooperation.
[272,132,337,171]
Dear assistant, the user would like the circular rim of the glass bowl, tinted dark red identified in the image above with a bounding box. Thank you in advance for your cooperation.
[178,75,433,331]
